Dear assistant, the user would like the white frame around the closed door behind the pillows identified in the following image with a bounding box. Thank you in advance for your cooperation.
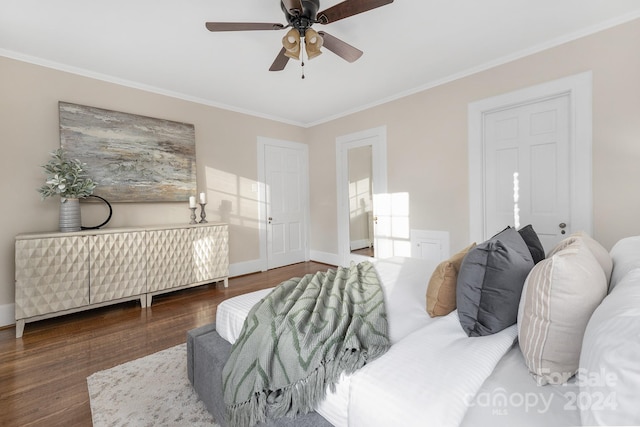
[468,71,593,242]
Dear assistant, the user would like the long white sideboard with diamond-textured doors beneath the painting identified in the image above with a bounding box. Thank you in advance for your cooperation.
[15,223,229,338]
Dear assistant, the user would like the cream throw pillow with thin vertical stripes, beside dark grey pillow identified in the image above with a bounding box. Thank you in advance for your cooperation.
[518,238,607,385]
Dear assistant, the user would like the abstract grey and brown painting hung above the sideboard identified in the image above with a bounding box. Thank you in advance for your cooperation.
[58,102,196,202]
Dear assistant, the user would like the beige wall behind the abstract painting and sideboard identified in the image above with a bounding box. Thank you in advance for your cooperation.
[0,57,304,314]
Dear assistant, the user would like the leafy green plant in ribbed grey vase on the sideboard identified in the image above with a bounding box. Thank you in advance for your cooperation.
[38,148,97,231]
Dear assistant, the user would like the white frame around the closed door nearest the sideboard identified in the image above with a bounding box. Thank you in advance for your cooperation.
[257,136,310,271]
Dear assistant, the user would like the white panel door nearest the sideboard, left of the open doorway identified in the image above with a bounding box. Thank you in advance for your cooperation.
[265,145,306,269]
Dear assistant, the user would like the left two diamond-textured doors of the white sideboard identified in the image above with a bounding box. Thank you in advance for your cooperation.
[15,232,146,319]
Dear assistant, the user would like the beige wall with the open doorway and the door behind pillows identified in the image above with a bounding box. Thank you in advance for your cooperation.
[307,16,640,253]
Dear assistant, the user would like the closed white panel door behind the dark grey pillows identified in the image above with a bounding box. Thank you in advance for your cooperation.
[484,95,571,251]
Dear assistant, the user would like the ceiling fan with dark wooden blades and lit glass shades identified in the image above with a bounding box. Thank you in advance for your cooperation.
[206,0,393,72]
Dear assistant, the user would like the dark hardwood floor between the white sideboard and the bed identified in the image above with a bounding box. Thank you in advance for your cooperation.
[0,262,330,427]
